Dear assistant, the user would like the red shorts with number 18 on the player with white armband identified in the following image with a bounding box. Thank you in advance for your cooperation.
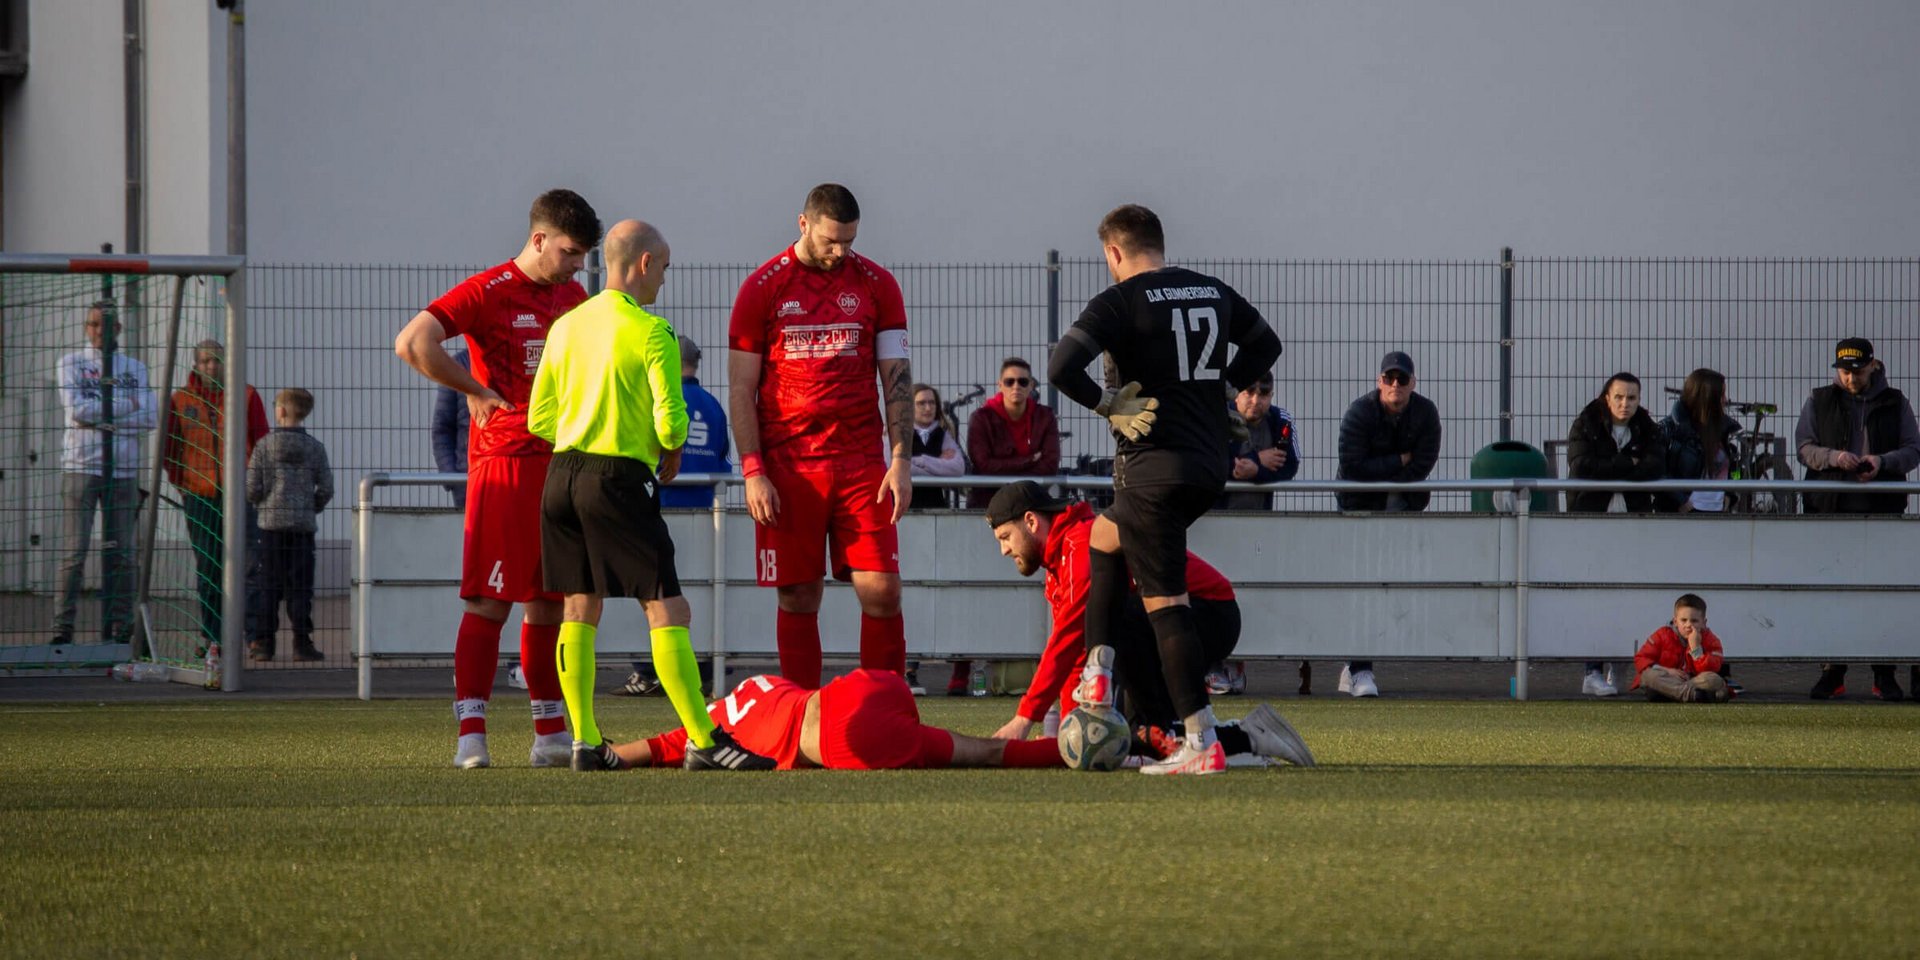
[753,461,900,588]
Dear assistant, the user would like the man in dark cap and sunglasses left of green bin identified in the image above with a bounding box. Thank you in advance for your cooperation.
[1334,349,1440,697]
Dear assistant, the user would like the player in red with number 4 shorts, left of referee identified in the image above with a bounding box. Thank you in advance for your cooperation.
[394,190,601,768]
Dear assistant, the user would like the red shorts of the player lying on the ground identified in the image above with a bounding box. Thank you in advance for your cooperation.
[820,670,954,770]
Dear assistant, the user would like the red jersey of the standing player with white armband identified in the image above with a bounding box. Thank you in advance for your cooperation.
[728,246,906,463]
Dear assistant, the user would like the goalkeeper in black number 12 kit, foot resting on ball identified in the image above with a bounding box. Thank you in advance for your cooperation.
[1048,204,1281,774]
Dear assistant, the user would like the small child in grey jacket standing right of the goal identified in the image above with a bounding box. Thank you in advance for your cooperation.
[246,386,334,660]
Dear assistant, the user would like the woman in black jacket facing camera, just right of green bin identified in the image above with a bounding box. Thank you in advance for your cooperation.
[1567,372,1667,697]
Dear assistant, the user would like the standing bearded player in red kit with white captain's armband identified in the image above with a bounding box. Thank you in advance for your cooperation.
[728,184,914,687]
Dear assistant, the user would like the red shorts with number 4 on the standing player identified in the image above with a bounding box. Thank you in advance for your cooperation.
[461,457,561,603]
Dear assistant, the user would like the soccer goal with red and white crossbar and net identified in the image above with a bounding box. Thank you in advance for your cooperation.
[0,253,250,689]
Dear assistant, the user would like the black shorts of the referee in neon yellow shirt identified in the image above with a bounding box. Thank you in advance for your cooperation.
[540,449,680,601]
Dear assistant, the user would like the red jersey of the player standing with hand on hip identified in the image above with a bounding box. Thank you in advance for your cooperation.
[426,259,588,459]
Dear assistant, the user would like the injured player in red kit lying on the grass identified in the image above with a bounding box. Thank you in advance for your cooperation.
[612,670,1066,770]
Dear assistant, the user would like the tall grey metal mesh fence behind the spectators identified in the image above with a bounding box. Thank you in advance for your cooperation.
[0,252,1920,662]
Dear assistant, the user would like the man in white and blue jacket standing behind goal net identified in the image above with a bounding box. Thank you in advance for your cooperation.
[54,300,159,643]
